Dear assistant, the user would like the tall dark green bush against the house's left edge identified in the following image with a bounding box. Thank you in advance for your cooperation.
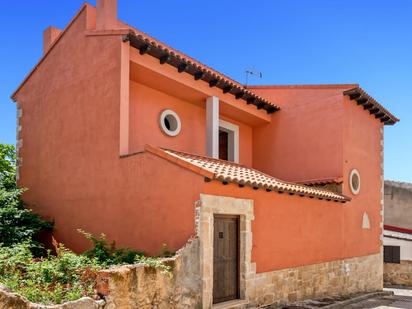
[0,144,53,255]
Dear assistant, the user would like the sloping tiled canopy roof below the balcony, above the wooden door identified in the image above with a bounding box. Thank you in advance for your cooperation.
[146,146,350,203]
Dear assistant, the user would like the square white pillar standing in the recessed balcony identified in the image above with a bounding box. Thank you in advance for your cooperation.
[206,96,219,159]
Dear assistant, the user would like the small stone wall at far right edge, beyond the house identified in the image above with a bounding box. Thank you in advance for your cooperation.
[383,261,412,286]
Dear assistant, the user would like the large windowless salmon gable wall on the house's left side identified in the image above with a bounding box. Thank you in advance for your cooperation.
[13,6,203,254]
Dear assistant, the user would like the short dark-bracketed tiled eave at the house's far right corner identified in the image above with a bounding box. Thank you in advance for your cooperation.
[343,87,399,125]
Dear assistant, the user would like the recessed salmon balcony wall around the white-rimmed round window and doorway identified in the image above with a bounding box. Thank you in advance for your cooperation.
[129,79,252,166]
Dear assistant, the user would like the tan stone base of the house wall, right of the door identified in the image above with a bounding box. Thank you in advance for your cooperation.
[248,254,383,306]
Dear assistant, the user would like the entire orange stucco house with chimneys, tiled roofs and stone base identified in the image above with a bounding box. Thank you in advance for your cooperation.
[12,0,398,308]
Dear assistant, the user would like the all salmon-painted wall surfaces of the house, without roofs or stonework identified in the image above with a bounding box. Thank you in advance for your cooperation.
[12,6,381,272]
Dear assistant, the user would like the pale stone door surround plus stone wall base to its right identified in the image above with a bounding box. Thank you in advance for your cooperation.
[196,194,383,308]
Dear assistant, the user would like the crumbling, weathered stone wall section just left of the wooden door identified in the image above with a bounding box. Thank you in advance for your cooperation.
[97,239,201,309]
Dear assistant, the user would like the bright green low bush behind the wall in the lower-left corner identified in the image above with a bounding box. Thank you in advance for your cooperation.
[0,243,101,304]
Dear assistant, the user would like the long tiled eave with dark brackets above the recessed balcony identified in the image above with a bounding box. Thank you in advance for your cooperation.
[123,29,279,114]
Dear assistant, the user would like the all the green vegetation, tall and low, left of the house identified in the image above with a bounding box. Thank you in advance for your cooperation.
[0,144,173,304]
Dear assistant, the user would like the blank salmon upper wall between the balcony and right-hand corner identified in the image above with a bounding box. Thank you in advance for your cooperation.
[250,86,350,181]
